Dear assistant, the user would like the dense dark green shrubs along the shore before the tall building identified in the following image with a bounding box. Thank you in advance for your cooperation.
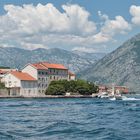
[46,80,98,95]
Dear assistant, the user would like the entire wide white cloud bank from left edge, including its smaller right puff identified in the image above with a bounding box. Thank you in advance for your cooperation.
[0,3,131,51]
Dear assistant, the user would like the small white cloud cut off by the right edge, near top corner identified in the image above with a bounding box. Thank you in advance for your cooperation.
[129,5,140,25]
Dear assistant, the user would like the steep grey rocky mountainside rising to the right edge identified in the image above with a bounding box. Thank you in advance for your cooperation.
[80,34,140,92]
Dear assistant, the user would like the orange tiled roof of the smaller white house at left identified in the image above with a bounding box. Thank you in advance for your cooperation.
[10,71,36,81]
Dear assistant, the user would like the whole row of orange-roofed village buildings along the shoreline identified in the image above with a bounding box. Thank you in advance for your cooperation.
[0,62,129,97]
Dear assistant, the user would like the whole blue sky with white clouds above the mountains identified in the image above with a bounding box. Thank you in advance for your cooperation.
[0,0,140,53]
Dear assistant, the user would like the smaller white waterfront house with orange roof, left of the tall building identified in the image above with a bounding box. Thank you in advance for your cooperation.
[2,71,38,97]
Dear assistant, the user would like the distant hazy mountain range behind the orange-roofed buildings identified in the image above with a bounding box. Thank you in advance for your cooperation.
[0,47,104,73]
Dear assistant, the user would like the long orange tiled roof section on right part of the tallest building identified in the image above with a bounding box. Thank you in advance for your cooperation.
[41,62,67,70]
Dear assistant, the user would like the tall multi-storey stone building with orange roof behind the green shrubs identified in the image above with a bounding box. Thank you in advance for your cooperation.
[22,62,69,95]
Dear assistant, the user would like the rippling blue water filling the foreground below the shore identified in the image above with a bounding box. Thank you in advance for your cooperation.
[0,98,140,140]
